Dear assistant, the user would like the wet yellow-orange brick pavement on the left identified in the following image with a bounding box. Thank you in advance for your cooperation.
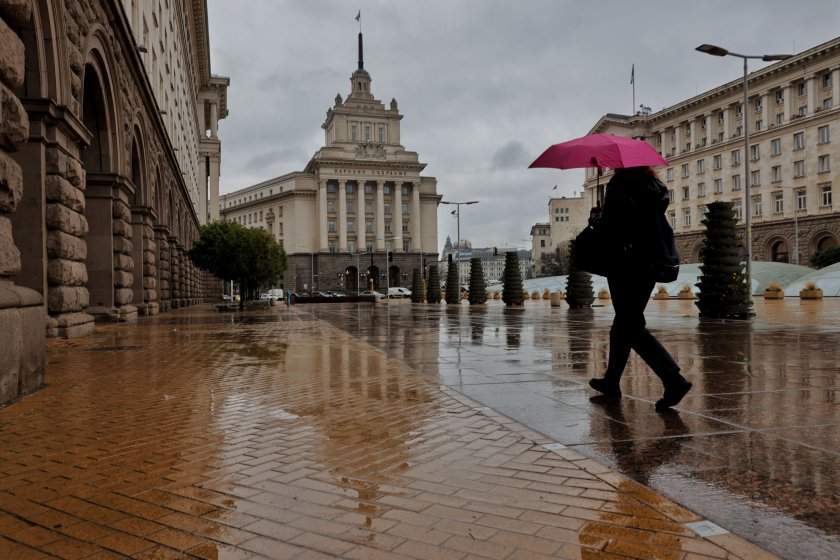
[0,304,772,560]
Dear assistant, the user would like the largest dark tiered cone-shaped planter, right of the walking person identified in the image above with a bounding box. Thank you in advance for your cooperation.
[697,202,752,318]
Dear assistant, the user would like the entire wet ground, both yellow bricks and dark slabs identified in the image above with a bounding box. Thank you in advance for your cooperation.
[0,301,828,560]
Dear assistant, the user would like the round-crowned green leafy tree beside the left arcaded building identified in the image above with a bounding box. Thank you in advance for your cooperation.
[189,221,286,309]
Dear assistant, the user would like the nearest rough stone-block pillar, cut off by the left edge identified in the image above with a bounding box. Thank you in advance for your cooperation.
[0,1,45,403]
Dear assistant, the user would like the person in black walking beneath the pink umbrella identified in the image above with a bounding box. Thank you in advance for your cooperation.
[589,167,691,411]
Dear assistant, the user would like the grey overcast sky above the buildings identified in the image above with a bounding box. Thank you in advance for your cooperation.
[207,0,840,247]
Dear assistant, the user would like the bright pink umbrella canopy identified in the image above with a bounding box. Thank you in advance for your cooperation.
[528,134,668,169]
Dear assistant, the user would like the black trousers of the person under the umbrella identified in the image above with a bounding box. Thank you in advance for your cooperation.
[604,271,681,385]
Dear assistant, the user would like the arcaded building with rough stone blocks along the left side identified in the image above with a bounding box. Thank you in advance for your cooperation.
[0,0,228,402]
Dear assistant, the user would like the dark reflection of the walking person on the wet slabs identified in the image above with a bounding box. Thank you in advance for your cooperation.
[589,395,691,486]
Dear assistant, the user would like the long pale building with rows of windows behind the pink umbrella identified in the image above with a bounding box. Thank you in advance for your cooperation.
[585,38,840,264]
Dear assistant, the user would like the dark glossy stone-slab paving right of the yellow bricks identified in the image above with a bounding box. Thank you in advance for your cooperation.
[306,298,840,558]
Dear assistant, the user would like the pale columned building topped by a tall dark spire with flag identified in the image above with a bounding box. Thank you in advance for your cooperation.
[220,33,441,293]
